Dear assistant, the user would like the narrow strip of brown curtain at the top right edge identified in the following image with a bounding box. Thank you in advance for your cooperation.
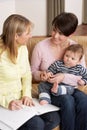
[82,0,87,24]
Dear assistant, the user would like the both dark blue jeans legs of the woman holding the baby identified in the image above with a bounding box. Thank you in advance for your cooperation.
[52,90,87,130]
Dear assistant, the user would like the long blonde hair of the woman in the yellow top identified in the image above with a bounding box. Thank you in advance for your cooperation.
[0,14,33,63]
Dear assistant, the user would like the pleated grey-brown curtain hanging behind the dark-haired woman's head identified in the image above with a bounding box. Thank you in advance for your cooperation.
[47,0,65,36]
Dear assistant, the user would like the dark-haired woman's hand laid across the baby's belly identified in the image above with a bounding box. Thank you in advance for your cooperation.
[47,73,64,84]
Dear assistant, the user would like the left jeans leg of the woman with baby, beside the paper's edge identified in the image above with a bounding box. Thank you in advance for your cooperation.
[52,95,75,130]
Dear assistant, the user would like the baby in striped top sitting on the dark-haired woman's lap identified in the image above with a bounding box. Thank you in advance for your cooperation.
[39,44,87,105]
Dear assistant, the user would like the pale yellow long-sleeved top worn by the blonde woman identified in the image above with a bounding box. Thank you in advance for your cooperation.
[0,45,32,108]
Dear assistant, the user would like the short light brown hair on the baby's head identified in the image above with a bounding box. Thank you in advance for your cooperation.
[66,44,84,60]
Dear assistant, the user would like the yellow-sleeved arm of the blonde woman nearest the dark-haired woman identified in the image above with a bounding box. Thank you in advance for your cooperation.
[20,47,32,98]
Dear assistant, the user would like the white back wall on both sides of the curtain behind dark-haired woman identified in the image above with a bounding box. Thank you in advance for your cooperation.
[15,0,82,36]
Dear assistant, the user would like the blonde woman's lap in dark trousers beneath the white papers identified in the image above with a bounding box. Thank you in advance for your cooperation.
[18,111,60,130]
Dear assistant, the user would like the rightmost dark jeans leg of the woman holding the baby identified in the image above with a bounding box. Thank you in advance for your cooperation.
[73,89,87,130]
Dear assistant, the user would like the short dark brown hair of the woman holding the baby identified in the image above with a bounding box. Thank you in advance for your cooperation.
[52,12,78,36]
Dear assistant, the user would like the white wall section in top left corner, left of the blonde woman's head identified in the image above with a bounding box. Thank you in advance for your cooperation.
[0,0,15,34]
